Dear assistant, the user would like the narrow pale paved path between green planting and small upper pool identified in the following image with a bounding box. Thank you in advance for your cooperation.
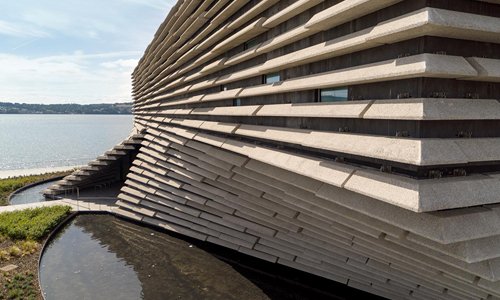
[0,198,117,213]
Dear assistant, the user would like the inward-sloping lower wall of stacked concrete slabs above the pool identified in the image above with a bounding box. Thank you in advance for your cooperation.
[116,127,500,299]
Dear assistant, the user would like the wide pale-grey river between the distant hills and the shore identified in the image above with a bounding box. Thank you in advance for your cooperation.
[0,114,133,171]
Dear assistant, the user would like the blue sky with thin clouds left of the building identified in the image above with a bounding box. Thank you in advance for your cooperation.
[0,0,175,104]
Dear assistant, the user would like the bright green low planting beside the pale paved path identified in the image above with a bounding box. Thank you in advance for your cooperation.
[0,205,71,241]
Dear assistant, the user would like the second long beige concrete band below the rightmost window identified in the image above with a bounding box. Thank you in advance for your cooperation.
[169,122,500,165]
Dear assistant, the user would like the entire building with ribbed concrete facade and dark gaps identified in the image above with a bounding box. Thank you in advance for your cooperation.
[47,0,500,300]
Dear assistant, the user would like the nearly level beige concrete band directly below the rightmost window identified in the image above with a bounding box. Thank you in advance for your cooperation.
[146,98,500,120]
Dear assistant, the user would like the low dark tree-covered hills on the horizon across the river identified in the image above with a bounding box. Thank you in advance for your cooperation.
[0,102,132,115]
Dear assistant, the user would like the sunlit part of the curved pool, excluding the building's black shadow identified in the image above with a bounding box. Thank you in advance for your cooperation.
[40,215,269,300]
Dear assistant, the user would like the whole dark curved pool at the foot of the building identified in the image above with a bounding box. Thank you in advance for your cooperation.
[40,215,368,300]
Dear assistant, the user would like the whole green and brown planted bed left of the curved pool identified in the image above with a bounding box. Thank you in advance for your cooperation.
[0,205,71,300]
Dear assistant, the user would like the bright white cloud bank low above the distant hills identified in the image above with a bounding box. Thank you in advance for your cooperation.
[0,51,137,103]
